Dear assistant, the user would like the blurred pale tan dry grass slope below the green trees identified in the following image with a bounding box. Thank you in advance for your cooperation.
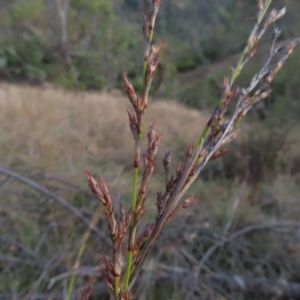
[0,83,207,174]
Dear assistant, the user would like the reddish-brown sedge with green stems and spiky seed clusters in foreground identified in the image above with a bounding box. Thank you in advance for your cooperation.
[82,0,300,300]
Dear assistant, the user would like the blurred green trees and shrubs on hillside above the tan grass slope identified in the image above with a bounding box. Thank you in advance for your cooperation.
[0,0,300,112]
